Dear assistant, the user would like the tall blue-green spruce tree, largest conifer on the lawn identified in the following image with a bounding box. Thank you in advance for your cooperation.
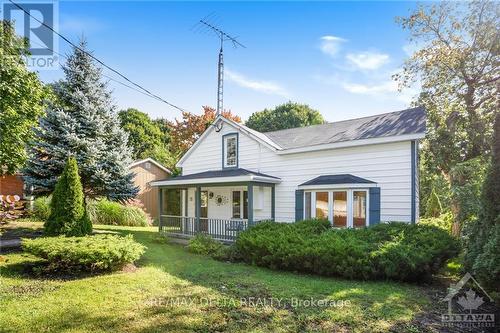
[24,40,138,200]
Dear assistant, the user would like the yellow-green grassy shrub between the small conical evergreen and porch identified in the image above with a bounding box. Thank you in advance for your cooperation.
[87,199,148,227]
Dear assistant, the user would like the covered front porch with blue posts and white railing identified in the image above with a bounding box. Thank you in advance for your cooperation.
[152,169,280,242]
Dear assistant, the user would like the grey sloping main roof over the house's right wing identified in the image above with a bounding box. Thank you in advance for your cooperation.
[263,107,426,149]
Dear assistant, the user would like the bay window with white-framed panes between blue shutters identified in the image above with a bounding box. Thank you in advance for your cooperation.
[304,189,368,228]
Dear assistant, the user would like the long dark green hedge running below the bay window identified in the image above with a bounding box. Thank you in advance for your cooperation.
[235,220,459,281]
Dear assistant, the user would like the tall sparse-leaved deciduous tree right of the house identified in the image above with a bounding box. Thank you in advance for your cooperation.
[395,1,500,230]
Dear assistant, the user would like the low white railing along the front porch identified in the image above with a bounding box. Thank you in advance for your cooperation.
[159,215,270,242]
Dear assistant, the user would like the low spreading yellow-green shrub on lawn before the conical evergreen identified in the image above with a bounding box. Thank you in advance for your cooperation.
[22,235,145,273]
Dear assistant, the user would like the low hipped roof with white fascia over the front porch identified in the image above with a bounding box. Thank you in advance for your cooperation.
[151,168,281,186]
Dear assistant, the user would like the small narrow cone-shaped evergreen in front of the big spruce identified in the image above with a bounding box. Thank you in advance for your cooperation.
[44,157,92,236]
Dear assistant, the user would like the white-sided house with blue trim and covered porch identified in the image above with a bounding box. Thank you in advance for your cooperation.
[153,108,425,240]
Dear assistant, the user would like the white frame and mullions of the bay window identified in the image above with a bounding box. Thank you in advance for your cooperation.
[302,187,370,228]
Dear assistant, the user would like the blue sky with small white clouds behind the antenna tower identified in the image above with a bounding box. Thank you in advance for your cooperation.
[28,1,416,121]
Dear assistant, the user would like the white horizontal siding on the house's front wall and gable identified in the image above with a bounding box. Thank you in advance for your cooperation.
[182,124,412,222]
